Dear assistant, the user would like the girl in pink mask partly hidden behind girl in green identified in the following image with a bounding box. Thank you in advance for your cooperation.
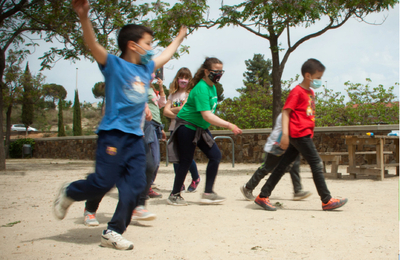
[164,68,200,192]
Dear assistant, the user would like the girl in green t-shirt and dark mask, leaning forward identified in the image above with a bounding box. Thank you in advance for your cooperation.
[167,58,242,206]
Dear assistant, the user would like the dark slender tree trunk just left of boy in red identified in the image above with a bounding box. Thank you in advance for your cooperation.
[269,36,282,127]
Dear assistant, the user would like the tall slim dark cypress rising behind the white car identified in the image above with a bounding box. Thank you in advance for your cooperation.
[21,63,33,134]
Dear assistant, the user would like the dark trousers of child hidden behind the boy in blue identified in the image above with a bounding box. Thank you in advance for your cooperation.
[85,138,156,213]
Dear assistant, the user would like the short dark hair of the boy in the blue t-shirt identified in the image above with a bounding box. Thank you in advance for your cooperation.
[118,24,153,55]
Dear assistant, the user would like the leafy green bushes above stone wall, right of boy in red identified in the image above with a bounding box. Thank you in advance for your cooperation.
[315,78,399,126]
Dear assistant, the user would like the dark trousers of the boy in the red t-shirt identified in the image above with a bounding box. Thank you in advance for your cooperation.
[260,136,332,203]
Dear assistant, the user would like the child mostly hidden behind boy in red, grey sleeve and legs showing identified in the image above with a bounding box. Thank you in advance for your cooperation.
[240,113,311,201]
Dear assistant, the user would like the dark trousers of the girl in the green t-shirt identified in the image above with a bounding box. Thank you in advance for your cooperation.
[171,126,221,194]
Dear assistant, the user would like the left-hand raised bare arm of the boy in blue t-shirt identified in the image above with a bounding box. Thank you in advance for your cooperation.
[72,0,107,65]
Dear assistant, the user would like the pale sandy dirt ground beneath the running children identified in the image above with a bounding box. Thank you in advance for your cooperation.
[0,159,399,260]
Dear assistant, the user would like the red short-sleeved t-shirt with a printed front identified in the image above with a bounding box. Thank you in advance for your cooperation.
[283,85,315,138]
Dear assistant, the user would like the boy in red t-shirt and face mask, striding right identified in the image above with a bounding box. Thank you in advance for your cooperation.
[254,59,347,211]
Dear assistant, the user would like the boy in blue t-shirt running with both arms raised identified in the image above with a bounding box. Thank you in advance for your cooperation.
[53,0,187,250]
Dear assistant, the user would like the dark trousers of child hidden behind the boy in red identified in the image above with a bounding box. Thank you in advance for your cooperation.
[246,153,302,193]
